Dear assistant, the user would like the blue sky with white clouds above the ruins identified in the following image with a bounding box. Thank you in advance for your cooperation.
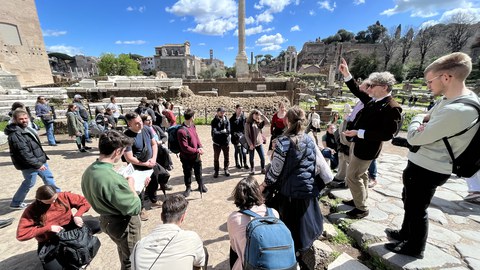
[35,0,480,66]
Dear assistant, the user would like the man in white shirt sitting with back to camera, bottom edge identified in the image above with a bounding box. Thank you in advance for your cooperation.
[130,194,208,270]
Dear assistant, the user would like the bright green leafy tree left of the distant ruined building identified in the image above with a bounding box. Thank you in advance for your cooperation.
[97,53,142,76]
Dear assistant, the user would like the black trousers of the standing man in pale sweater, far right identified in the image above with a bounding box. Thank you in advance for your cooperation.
[400,161,450,252]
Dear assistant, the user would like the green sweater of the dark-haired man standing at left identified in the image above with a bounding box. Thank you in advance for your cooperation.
[82,160,141,216]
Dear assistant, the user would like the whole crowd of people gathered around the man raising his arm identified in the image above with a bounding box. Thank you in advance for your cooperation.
[5,53,480,269]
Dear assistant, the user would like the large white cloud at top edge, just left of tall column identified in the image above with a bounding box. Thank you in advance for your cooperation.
[165,0,237,35]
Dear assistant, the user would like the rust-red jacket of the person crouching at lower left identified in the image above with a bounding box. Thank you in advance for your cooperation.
[17,192,90,242]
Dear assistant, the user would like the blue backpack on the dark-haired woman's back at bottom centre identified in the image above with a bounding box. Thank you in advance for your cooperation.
[239,207,297,270]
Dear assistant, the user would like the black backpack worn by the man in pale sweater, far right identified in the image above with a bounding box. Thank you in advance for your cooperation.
[442,98,480,177]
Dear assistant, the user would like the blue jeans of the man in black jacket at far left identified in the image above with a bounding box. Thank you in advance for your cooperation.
[10,163,60,206]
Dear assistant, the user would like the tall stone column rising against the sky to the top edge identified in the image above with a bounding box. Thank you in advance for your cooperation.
[235,0,249,79]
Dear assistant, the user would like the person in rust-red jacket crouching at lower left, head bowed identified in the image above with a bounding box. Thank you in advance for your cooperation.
[17,185,100,269]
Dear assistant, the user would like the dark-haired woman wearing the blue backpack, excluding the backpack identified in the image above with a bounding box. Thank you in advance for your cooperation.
[227,175,279,270]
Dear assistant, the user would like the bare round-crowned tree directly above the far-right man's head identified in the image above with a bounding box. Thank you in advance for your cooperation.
[447,12,475,52]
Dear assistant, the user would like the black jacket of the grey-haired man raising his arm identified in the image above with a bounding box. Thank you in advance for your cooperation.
[346,79,402,160]
